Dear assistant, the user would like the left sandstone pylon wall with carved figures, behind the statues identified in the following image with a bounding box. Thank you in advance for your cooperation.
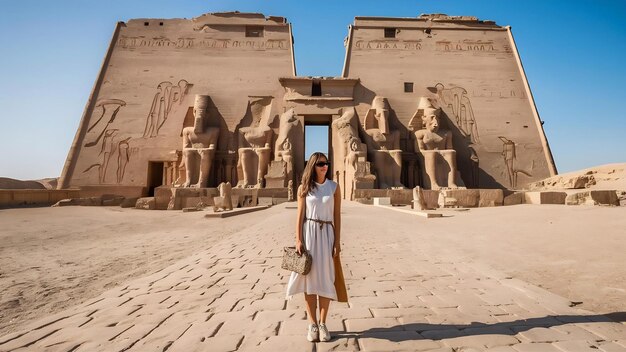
[59,13,295,188]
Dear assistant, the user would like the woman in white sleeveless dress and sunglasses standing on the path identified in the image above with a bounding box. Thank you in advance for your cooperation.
[287,152,347,342]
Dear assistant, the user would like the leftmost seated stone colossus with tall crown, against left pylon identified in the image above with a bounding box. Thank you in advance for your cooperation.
[183,95,220,188]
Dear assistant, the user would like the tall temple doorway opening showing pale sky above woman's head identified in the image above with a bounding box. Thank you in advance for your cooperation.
[302,115,333,179]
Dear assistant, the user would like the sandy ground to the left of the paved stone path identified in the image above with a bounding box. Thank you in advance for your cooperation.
[0,206,272,335]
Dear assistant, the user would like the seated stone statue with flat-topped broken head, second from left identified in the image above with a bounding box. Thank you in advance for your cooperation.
[237,97,273,188]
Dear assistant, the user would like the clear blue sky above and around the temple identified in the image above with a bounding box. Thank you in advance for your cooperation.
[0,0,626,179]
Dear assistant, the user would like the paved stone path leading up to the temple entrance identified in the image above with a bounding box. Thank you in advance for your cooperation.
[0,202,626,352]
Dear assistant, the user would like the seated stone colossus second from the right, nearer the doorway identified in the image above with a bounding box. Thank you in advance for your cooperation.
[363,96,403,188]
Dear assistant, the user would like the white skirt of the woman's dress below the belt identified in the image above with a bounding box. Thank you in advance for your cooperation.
[287,220,337,301]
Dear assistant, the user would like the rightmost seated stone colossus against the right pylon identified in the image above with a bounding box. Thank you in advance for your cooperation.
[409,97,458,190]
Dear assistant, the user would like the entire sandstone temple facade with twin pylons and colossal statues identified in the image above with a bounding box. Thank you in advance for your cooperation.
[59,12,556,207]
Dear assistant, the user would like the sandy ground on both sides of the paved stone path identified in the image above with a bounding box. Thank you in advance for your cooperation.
[0,202,626,336]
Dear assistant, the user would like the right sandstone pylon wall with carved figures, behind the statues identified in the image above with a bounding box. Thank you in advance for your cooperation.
[343,15,556,188]
